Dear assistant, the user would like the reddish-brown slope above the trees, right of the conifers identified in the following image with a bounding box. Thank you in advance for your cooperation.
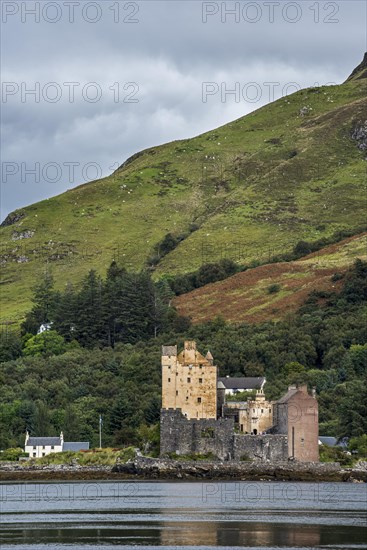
[173,233,367,323]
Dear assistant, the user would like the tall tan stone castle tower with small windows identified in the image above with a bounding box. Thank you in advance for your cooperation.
[162,340,217,419]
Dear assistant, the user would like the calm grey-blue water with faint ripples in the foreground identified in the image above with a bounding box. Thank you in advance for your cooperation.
[0,482,367,550]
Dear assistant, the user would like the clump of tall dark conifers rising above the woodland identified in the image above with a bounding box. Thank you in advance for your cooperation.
[22,261,187,348]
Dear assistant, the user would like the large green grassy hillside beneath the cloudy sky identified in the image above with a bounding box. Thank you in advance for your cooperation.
[1,57,367,322]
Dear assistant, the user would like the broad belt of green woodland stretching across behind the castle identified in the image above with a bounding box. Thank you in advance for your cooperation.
[0,260,367,448]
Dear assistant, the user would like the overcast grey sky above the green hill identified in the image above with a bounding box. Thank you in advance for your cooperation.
[1,0,367,223]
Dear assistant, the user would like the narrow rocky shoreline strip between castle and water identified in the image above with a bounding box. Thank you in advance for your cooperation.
[0,457,367,482]
